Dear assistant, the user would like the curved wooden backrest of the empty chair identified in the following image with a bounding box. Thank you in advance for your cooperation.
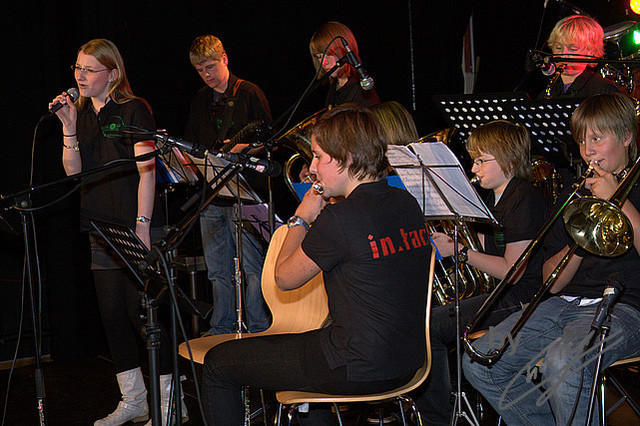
[262,225,329,334]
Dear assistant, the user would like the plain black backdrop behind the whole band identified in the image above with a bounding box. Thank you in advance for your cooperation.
[0,0,638,358]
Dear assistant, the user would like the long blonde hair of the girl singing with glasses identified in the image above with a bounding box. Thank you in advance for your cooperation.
[77,38,145,110]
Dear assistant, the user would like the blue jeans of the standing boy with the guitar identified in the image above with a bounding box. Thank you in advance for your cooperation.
[200,205,269,334]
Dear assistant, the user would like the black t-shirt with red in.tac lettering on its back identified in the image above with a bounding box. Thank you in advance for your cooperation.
[302,180,431,381]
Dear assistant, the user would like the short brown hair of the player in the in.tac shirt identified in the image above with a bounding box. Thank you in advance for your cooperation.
[311,104,389,179]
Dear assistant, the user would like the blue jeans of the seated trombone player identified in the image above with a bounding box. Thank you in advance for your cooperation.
[462,297,640,426]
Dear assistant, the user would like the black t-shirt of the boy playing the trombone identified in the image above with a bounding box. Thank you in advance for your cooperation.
[545,178,640,310]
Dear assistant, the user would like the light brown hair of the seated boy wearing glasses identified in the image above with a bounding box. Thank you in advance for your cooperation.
[467,120,531,179]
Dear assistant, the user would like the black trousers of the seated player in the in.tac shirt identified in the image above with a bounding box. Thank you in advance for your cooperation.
[202,331,414,426]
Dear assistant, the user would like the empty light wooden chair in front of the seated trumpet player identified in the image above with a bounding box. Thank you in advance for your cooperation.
[178,226,329,364]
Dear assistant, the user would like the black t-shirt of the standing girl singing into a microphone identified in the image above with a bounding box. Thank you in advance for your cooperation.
[77,99,155,230]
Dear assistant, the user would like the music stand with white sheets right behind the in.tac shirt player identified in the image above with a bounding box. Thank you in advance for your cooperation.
[387,142,497,426]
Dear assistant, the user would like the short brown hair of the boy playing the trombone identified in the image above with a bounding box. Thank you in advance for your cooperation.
[571,93,638,161]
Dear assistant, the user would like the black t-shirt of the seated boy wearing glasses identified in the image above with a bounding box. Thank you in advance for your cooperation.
[479,178,547,303]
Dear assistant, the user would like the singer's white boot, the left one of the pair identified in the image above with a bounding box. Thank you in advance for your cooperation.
[93,367,149,426]
